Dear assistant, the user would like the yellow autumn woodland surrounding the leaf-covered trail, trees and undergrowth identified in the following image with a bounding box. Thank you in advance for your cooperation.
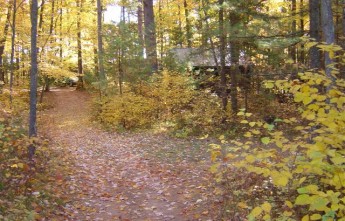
[0,0,345,220]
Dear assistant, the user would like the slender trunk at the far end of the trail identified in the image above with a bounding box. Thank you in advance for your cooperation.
[76,0,84,90]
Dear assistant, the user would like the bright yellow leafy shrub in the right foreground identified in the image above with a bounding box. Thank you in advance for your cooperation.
[211,48,345,221]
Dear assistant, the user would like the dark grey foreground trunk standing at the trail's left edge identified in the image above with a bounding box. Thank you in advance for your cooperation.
[28,0,38,160]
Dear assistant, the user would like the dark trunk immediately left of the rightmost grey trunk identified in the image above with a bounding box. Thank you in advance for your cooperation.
[309,0,321,69]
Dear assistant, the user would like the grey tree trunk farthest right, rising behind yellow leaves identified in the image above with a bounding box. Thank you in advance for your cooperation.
[321,0,335,81]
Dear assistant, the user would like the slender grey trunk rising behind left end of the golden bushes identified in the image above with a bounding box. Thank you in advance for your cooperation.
[97,0,106,93]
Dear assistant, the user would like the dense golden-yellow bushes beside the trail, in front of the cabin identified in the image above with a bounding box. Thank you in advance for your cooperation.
[97,71,223,136]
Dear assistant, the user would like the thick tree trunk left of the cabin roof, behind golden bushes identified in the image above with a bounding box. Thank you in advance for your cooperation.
[143,0,158,73]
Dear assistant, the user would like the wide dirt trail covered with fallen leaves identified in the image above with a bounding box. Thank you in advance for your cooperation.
[39,88,218,221]
